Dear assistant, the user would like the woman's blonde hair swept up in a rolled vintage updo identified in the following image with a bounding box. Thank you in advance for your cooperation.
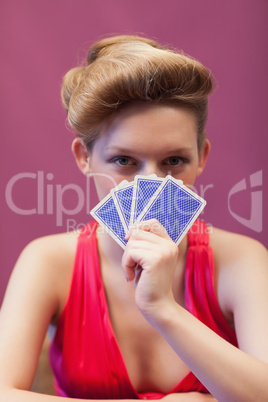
[61,35,213,149]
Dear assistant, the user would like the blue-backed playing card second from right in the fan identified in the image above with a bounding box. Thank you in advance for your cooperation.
[130,174,164,225]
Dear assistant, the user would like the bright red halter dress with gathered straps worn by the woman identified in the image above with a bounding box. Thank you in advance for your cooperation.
[50,220,237,399]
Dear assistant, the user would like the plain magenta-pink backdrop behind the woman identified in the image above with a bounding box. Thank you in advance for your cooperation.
[0,0,268,302]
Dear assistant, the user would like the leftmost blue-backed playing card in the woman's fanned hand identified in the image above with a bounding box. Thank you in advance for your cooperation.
[90,194,127,249]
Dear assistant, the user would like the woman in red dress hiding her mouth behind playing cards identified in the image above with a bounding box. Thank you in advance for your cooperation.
[0,36,268,402]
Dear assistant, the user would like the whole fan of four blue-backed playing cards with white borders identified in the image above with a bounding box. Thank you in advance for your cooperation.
[90,175,206,249]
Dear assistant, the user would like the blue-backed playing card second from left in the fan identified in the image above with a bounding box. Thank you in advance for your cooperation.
[111,180,134,233]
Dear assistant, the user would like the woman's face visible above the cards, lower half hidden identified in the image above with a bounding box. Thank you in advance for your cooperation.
[89,102,209,199]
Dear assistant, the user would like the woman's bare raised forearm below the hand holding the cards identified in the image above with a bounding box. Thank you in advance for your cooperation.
[145,304,268,402]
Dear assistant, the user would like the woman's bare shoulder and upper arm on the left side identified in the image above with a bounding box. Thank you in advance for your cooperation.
[0,233,78,389]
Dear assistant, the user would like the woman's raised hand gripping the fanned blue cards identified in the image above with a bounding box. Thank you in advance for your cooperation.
[122,219,179,316]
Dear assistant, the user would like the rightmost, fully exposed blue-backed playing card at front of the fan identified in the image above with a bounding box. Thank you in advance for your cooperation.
[137,176,206,244]
